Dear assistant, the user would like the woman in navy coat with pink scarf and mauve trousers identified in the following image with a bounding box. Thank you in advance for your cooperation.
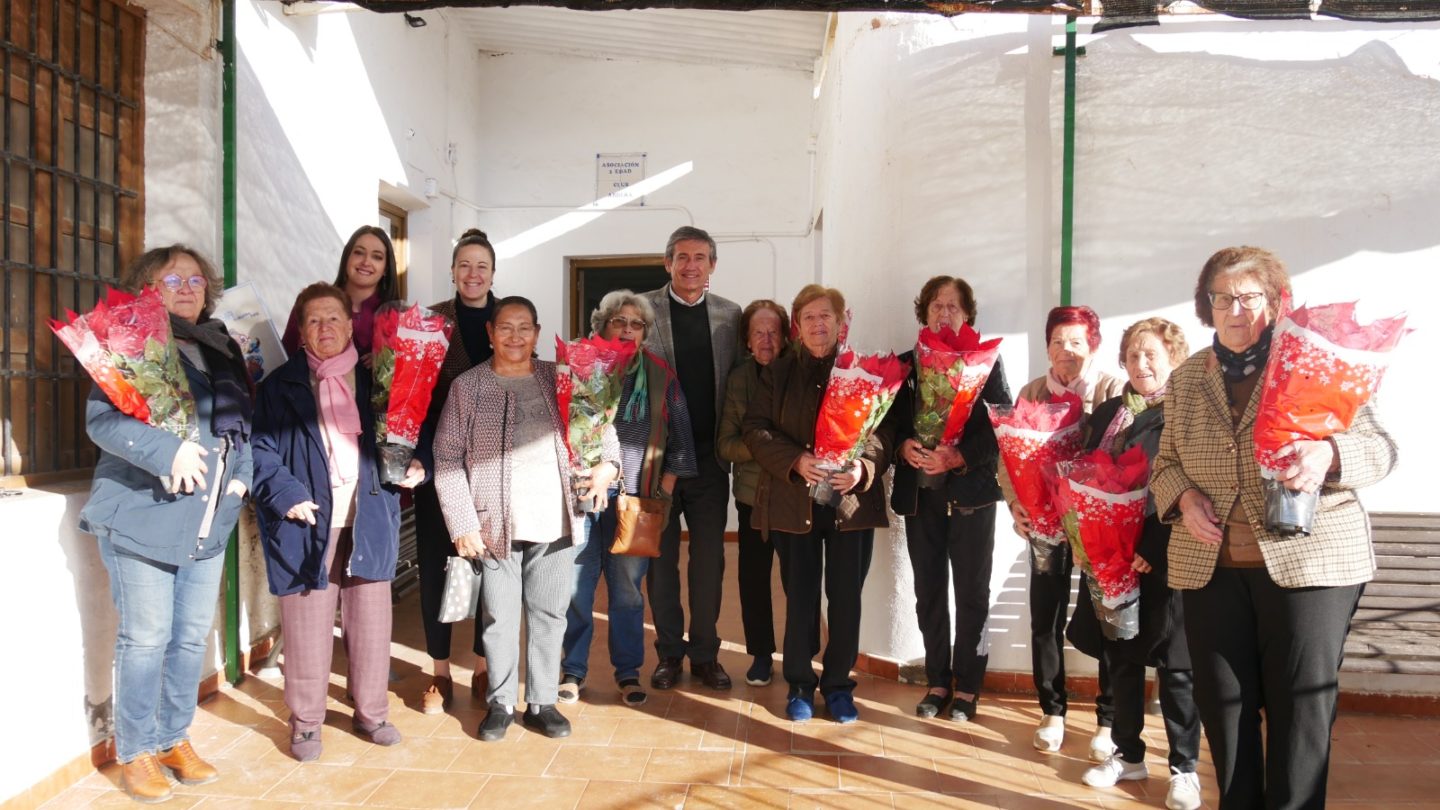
[255,284,428,761]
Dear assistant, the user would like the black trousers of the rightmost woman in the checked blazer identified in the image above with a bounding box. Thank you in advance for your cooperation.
[1185,568,1364,810]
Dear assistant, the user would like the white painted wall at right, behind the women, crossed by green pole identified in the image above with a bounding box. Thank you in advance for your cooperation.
[818,14,1440,672]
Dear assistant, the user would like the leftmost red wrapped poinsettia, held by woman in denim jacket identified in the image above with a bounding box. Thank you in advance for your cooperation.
[50,290,199,441]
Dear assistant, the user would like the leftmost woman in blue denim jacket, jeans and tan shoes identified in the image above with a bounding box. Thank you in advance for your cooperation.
[81,245,251,801]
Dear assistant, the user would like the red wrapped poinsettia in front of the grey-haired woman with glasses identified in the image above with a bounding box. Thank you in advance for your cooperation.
[554,336,639,470]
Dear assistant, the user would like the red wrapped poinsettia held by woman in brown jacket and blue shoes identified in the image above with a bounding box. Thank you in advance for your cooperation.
[815,349,910,467]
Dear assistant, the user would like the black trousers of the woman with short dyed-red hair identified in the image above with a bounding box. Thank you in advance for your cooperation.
[1025,546,1115,726]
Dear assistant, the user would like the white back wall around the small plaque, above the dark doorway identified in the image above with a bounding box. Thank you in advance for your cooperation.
[456,55,814,335]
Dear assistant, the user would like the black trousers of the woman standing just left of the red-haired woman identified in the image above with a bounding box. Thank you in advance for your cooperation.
[904,489,995,695]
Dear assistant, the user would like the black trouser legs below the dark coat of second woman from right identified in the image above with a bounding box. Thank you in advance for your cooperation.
[1109,659,1200,774]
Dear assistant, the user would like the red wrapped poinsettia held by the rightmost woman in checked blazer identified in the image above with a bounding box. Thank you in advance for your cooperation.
[1254,301,1411,476]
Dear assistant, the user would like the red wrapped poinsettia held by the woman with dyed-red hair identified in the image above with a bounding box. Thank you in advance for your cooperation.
[985,393,1084,543]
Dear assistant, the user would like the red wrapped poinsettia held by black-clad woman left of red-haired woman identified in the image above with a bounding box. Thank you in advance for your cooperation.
[914,323,1001,450]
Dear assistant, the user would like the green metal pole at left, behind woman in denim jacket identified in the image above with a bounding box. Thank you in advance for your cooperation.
[220,0,245,685]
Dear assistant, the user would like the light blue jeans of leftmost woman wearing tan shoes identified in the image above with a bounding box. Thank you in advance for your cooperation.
[99,536,225,762]
